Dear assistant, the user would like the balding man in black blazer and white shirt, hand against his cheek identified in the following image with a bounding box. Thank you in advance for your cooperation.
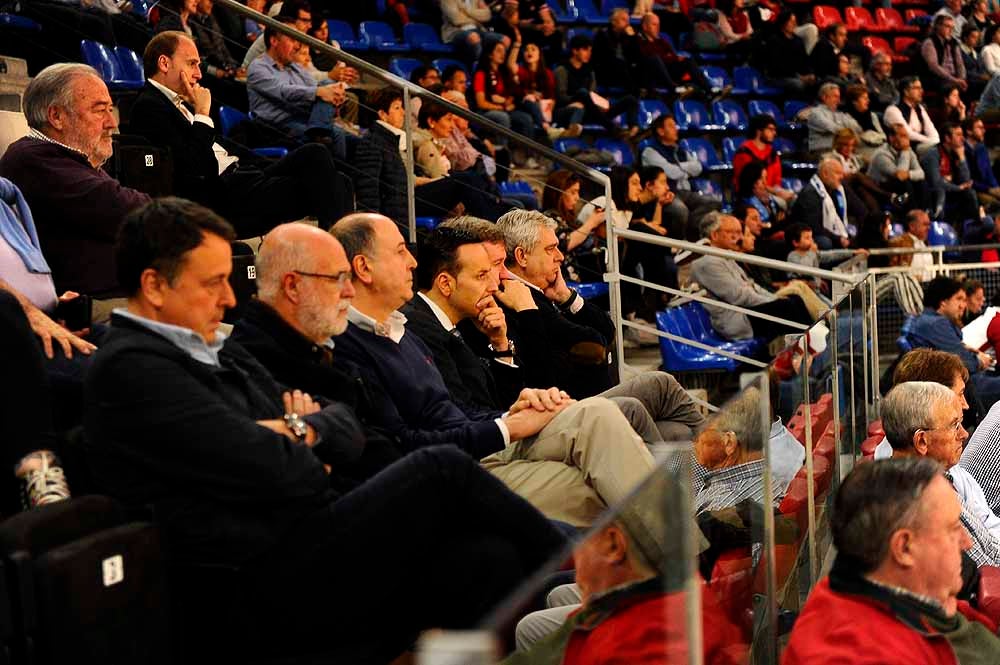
[129,31,350,237]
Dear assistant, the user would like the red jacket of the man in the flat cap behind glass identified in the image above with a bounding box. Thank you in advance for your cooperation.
[562,584,747,665]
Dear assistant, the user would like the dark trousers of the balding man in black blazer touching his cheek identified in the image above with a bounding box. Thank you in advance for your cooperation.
[220,143,353,238]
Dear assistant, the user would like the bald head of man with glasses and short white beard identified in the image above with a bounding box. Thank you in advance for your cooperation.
[256,223,354,343]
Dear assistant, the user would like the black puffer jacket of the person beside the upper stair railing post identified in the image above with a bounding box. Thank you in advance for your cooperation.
[354,123,408,223]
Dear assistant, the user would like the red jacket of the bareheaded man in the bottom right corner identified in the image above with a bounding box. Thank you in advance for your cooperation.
[781,578,996,665]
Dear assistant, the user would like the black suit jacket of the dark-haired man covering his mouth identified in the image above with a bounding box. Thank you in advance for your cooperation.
[400,295,524,410]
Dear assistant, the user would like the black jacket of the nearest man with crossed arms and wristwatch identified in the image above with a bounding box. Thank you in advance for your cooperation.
[84,316,363,564]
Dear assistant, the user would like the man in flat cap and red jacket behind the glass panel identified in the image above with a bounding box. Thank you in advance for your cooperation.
[501,468,746,665]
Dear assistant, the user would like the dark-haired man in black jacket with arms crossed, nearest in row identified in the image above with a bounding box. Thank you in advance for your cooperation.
[86,199,563,662]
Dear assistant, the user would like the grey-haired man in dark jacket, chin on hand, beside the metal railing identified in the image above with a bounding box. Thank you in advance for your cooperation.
[497,210,614,397]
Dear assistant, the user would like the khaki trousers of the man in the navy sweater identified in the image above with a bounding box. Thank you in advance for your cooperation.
[481,397,655,526]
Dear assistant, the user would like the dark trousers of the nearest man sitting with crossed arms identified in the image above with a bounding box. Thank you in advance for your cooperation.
[254,446,564,663]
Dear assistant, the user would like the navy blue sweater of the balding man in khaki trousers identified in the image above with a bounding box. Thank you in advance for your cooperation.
[334,323,504,459]
